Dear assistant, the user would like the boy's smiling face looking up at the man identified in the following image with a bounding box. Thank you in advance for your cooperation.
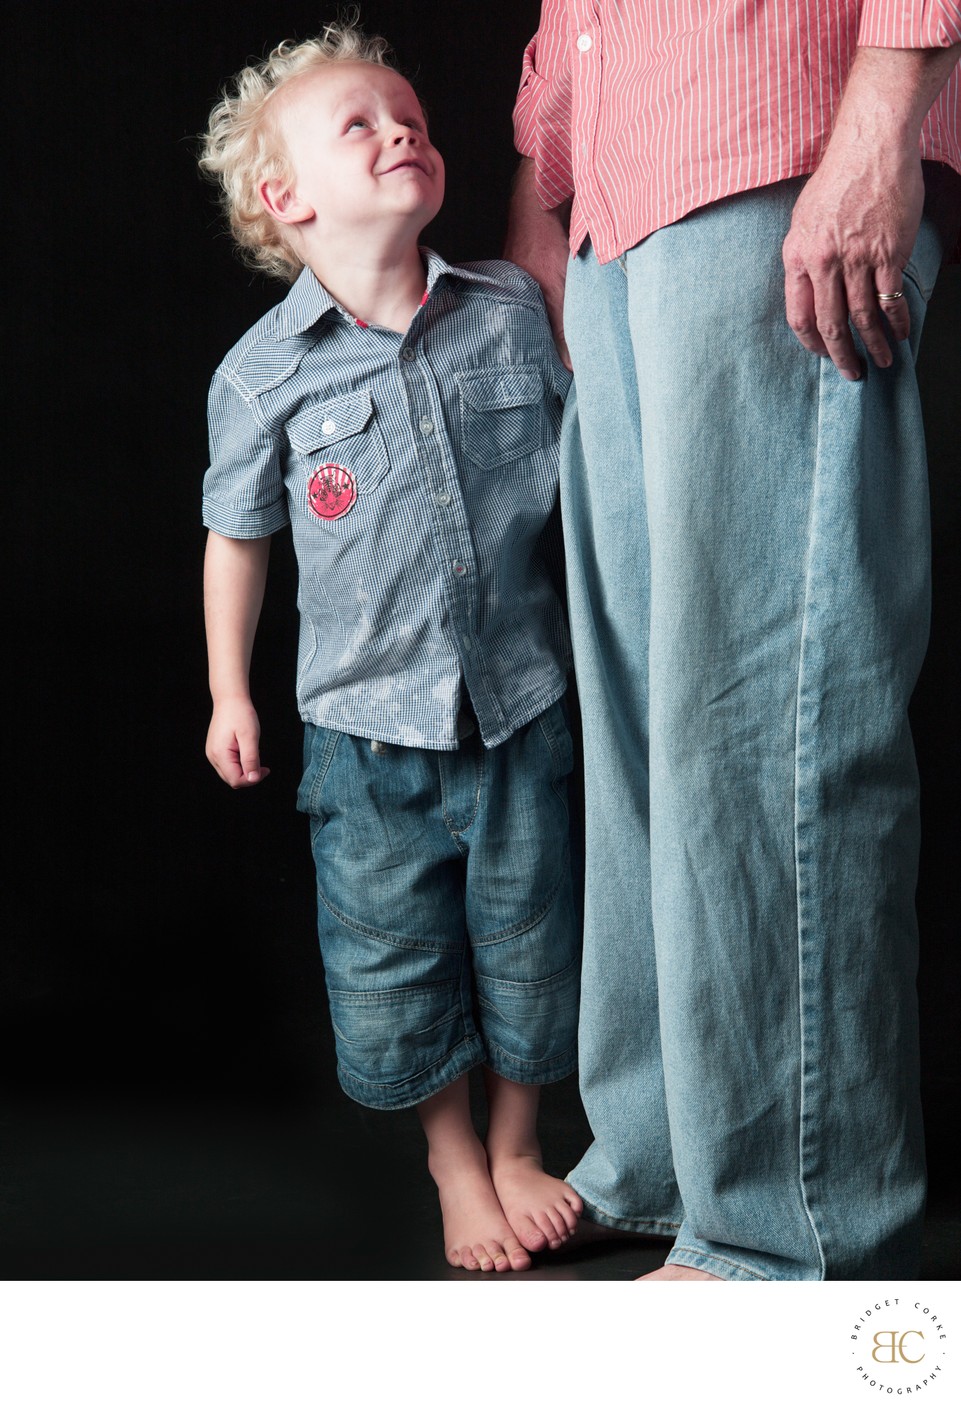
[279,62,444,240]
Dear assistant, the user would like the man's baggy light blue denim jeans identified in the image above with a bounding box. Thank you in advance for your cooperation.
[562,167,946,1281]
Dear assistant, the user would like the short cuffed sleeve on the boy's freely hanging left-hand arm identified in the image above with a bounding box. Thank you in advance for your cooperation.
[203,371,289,538]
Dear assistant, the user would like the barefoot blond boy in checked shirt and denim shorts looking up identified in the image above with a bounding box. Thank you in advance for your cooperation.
[202,25,582,1271]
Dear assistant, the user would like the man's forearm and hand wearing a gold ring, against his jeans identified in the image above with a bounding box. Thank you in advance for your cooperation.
[782,45,961,382]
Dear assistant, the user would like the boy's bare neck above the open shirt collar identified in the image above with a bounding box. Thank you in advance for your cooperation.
[307,241,427,333]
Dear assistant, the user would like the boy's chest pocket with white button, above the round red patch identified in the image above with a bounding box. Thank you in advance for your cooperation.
[287,392,390,517]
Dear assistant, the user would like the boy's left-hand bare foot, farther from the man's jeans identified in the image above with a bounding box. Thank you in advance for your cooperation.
[428,1137,531,1272]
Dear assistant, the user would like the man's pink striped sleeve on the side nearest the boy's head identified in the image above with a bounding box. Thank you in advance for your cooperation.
[514,0,574,210]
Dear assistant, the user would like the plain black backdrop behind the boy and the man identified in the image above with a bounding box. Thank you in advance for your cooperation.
[7,0,961,1262]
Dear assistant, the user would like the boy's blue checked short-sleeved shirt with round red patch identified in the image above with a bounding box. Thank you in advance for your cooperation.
[203,251,571,750]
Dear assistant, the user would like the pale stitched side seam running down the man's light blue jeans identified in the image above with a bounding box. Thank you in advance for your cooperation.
[793,359,834,1281]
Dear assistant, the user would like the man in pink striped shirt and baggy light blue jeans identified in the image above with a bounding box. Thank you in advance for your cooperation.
[507,0,961,1281]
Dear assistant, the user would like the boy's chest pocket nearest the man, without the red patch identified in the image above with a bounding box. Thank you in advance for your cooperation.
[457,365,551,465]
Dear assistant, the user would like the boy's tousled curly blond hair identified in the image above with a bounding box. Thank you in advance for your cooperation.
[199,14,396,283]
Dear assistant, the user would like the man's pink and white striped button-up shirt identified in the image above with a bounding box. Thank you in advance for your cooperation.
[514,0,961,263]
